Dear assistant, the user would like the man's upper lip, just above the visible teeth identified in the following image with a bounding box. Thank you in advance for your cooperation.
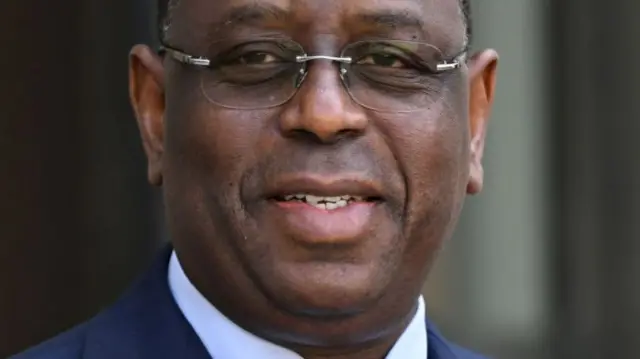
[266,175,383,200]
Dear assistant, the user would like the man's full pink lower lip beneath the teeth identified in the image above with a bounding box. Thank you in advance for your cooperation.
[272,201,377,244]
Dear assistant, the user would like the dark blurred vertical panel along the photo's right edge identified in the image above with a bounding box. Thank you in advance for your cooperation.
[549,0,640,359]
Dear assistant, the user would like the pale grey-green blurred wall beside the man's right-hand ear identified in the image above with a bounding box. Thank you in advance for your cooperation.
[426,0,552,359]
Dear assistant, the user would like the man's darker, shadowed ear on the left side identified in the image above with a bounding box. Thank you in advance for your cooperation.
[129,45,165,186]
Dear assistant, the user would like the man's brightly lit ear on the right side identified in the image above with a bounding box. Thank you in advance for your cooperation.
[467,50,498,194]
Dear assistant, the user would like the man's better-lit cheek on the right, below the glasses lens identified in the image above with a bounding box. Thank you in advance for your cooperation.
[382,102,468,248]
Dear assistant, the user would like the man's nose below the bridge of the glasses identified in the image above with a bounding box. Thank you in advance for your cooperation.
[280,61,368,143]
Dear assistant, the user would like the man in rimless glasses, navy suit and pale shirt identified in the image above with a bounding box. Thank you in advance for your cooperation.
[16,0,497,359]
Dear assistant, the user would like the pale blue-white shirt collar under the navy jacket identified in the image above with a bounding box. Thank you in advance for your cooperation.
[168,252,427,359]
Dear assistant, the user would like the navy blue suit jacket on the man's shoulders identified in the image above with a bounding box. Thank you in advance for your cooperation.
[10,248,483,359]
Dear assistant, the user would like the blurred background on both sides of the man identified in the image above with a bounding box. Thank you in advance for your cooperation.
[0,0,640,359]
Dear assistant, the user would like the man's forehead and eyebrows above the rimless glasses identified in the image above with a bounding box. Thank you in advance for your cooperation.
[170,0,465,46]
